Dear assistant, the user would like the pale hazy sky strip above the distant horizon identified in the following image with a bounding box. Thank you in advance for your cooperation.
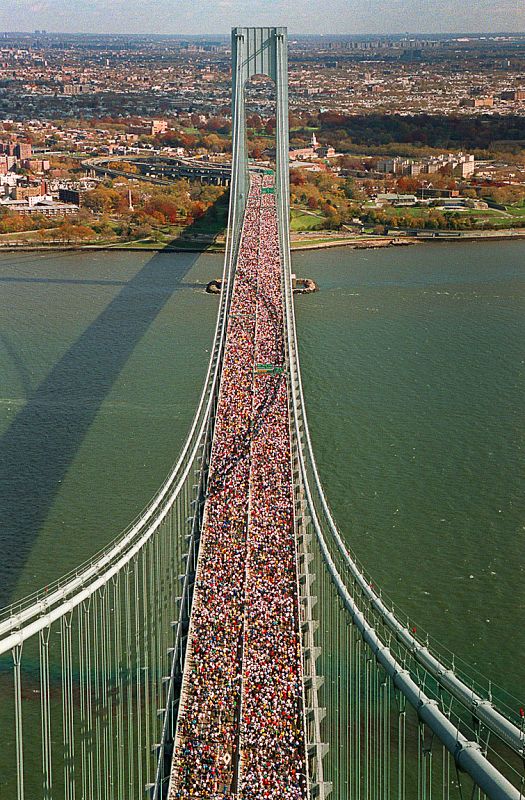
[0,0,525,35]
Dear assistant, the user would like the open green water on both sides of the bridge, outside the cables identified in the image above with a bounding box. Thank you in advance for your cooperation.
[0,242,525,696]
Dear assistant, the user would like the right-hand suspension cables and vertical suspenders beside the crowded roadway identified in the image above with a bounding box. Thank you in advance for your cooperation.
[282,197,525,800]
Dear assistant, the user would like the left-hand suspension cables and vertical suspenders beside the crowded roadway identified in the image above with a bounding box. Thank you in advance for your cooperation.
[0,159,244,800]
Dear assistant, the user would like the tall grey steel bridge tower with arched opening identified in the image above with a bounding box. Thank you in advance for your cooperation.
[230,27,290,269]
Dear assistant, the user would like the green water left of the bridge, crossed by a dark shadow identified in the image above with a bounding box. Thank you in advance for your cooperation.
[0,253,217,602]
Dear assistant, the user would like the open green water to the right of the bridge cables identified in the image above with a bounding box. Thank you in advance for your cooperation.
[295,242,525,711]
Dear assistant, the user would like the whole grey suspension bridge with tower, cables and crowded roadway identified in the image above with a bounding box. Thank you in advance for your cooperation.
[0,28,525,800]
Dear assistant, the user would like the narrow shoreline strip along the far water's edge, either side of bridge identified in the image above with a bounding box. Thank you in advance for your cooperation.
[0,229,525,255]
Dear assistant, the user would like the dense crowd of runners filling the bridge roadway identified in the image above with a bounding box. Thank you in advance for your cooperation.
[170,175,306,800]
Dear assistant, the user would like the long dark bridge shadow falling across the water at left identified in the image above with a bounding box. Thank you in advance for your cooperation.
[0,202,226,608]
